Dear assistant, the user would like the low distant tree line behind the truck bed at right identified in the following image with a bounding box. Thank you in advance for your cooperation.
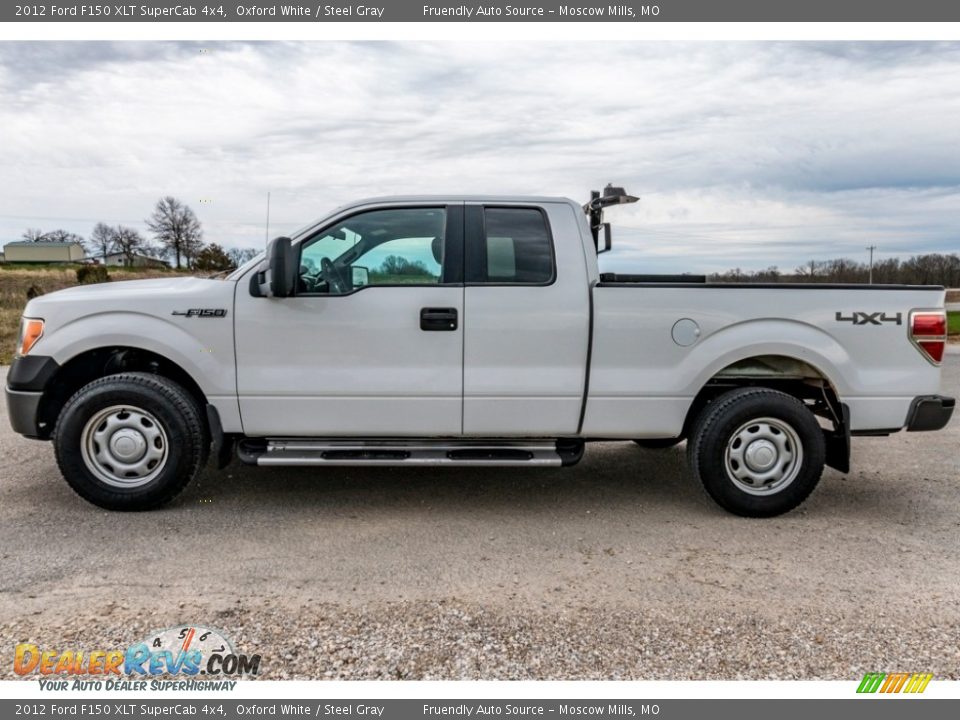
[709,253,960,288]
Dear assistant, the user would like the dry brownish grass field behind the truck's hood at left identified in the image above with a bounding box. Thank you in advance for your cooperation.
[0,263,193,365]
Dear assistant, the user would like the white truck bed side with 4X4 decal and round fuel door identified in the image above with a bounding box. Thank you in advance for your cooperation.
[583,284,945,437]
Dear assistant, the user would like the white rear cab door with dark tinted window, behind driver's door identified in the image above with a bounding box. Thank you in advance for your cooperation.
[463,202,590,437]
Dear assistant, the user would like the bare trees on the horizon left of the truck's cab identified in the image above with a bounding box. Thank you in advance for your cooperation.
[21,195,259,272]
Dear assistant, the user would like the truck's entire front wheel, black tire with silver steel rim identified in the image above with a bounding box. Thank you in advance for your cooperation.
[53,372,209,510]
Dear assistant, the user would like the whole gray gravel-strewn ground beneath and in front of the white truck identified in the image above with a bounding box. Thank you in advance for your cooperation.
[0,360,960,680]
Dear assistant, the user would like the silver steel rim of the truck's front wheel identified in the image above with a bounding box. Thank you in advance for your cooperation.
[80,405,170,488]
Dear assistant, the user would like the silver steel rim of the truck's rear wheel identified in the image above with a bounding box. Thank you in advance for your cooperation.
[724,417,803,495]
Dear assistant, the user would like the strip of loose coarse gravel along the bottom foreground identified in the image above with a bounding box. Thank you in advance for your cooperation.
[2,600,960,680]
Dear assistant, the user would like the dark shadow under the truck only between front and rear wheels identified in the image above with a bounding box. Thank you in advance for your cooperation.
[188,442,713,513]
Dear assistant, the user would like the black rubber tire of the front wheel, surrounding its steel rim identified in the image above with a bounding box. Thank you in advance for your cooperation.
[53,372,210,510]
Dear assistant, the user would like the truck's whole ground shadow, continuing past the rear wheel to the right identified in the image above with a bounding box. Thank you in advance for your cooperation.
[182,442,952,522]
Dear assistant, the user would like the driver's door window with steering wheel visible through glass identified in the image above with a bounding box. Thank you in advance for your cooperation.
[298,208,446,295]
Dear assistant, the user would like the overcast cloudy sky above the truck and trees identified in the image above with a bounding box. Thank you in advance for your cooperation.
[0,42,960,271]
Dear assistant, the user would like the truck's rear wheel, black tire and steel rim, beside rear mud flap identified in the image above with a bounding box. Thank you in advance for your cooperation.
[687,388,825,518]
